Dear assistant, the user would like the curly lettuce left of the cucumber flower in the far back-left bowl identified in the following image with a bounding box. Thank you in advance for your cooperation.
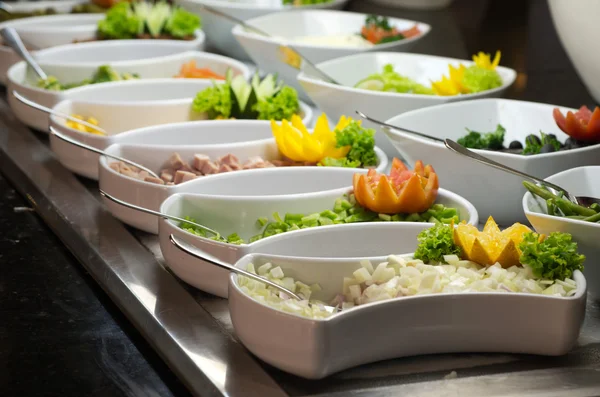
[98,2,143,39]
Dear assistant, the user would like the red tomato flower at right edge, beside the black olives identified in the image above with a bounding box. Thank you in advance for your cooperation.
[552,106,600,142]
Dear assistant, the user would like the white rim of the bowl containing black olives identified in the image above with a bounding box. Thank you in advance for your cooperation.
[382,98,600,162]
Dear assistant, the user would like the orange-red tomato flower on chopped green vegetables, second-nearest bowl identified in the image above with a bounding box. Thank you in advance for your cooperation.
[352,158,439,214]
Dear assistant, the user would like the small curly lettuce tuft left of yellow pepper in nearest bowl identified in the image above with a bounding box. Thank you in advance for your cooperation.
[414,224,461,263]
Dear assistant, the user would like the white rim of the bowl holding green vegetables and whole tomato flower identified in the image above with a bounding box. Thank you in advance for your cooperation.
[160,185,479,249]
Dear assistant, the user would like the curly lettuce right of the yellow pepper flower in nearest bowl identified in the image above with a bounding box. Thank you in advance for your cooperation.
[519,232,585,280]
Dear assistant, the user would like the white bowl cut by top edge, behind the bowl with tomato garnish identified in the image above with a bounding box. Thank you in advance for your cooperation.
[175,0,348,61]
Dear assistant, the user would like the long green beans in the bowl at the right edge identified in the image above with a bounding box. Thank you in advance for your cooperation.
[523,181,600,223]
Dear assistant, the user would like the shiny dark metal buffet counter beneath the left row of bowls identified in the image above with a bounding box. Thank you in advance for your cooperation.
[0,91,600,397]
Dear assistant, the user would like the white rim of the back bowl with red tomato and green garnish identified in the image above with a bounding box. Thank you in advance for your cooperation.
[231,9,432,52]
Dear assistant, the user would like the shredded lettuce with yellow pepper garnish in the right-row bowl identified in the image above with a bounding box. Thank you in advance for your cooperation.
[354,51,502,96]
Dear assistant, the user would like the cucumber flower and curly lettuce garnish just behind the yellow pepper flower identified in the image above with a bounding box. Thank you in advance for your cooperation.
[192,71,300,120]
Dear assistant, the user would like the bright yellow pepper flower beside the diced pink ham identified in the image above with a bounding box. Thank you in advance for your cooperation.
[271,114,353,163]
